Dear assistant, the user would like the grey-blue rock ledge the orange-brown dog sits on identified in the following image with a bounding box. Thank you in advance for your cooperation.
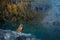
[0,29,37,40]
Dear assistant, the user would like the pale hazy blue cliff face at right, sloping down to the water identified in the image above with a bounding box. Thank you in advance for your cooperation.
[43,0,60,26]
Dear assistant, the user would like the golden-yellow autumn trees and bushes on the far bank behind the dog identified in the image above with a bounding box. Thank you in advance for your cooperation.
[1,0,36,23]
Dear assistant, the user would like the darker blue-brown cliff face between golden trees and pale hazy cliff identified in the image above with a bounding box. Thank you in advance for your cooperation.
[27,0,52,23]
